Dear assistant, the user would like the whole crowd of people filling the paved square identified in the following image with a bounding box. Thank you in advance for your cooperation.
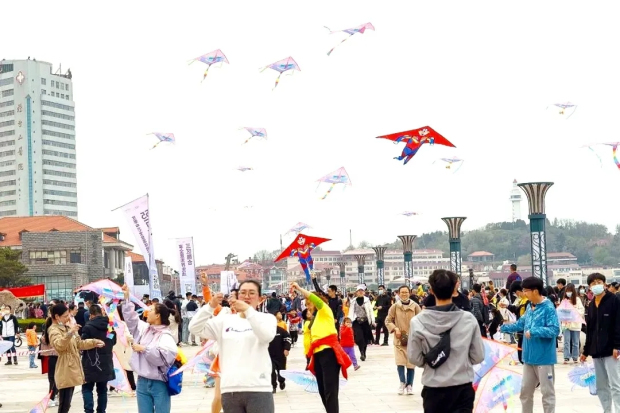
[0,266,620,413]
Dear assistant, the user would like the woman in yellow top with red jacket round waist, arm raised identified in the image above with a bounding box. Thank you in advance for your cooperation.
[291,282,352,413]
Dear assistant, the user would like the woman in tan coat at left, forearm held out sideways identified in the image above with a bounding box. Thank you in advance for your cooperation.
[46,304,105,413]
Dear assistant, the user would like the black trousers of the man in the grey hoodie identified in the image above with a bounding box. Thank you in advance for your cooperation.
[422,383,476,413]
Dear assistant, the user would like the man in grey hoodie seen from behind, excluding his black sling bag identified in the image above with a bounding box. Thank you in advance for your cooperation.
[407,270,484,413]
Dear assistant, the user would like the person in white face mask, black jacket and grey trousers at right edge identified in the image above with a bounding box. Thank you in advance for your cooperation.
[580,273,620,413]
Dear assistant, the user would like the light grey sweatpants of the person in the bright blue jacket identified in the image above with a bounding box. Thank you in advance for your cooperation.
[520,364,555,413]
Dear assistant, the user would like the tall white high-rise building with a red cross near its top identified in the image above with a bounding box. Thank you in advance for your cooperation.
[0,58,78,217]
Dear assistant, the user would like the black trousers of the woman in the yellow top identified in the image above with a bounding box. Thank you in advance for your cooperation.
[314,348,340,413]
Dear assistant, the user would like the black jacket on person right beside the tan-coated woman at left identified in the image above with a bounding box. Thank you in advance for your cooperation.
[82,316,116,383]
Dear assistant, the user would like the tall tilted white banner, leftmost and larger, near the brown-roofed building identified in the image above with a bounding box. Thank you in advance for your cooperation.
[116,194,162,298]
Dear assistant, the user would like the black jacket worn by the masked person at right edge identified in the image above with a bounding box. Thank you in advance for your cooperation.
[583,291,620,358]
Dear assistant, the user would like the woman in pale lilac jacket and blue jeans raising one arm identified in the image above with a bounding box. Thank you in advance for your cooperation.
[122,284,178,413]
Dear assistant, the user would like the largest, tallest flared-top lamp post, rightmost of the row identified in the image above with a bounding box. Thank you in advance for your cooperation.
[518,182,553,287]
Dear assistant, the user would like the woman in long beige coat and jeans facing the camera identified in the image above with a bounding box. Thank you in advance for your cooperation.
[385,285,422,396]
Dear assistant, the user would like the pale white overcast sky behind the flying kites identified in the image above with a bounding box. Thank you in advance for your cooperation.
[0,0,620,267]
